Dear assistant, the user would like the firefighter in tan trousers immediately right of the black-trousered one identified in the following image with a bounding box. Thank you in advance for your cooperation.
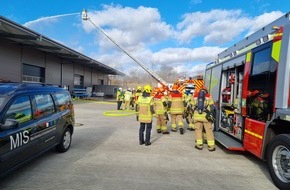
[154,88,169,134]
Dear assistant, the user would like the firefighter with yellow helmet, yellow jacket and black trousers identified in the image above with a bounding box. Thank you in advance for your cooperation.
[135,85,155,146]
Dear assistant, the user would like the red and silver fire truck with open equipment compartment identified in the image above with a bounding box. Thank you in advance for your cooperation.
[204,12,290,190]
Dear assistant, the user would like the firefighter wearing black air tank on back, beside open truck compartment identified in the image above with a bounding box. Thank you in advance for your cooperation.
[192,87,215,151]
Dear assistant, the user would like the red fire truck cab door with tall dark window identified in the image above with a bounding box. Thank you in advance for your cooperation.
[243,42,277,157]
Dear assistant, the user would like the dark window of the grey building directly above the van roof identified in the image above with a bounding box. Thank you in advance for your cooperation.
[22,63,45,83]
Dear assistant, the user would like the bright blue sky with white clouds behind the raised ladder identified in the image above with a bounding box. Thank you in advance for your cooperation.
[0,0,290,76]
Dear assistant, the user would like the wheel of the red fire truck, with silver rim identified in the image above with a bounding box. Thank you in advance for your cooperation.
[267,134,290,189]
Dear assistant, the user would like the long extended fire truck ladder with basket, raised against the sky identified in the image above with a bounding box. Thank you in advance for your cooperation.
[82,10,169,87]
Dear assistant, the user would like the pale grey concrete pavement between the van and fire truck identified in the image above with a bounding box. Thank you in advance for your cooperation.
[0,101,277,190]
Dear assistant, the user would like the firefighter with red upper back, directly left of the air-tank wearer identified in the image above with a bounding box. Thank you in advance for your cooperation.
[168,85,185,135]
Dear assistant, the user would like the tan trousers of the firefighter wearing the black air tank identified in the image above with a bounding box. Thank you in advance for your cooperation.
[194,121,215,148]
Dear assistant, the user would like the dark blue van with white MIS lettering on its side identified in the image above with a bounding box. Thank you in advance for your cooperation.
[0,83,75,176]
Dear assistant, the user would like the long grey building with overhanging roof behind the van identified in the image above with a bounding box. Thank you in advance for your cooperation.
[0,16,124,91]
